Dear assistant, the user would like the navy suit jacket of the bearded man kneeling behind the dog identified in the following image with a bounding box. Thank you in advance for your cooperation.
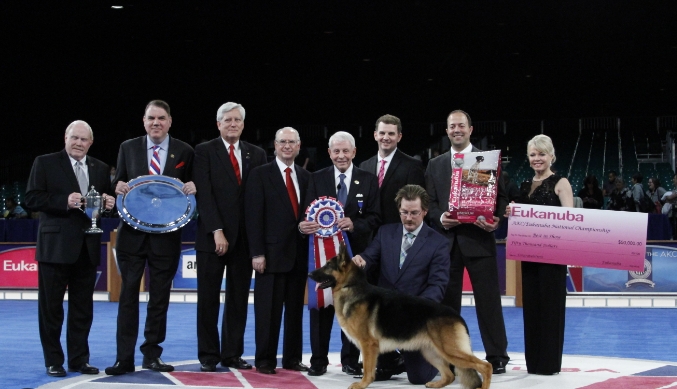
[360,223,450,302]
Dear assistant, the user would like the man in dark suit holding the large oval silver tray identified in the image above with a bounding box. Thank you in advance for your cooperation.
[106,100,196,375]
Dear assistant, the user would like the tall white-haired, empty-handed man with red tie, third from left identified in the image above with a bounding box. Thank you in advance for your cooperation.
[193,102,266,372]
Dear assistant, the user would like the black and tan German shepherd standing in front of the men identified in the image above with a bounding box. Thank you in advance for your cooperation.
[308,244,492,389]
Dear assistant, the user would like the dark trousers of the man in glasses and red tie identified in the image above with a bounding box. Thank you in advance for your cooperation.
[254,259,308,367]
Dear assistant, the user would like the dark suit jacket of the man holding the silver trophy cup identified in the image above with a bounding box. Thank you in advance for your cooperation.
[26,150,113,266]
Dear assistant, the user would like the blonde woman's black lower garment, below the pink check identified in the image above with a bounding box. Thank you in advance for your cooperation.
[522,262,567,374]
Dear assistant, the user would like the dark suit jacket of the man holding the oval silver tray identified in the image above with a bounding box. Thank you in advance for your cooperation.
[113,135,193,256]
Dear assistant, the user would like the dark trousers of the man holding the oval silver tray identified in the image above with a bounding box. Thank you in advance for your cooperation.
[117,239,180,364]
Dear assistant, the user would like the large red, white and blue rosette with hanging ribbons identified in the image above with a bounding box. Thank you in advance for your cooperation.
[306,196,352,309]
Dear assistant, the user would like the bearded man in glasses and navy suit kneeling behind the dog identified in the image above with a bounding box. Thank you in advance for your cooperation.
[353,185,449,385]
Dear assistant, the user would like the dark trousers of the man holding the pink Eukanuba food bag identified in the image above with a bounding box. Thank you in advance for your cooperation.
[442,242,510,363]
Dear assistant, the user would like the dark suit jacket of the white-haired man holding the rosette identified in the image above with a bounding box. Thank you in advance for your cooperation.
[302,165,381,253]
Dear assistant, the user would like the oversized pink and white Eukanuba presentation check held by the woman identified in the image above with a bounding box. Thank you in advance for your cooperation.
[506,203,648,271]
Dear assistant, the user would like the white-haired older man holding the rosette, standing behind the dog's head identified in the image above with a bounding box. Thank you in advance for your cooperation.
[299,131,380,376]
